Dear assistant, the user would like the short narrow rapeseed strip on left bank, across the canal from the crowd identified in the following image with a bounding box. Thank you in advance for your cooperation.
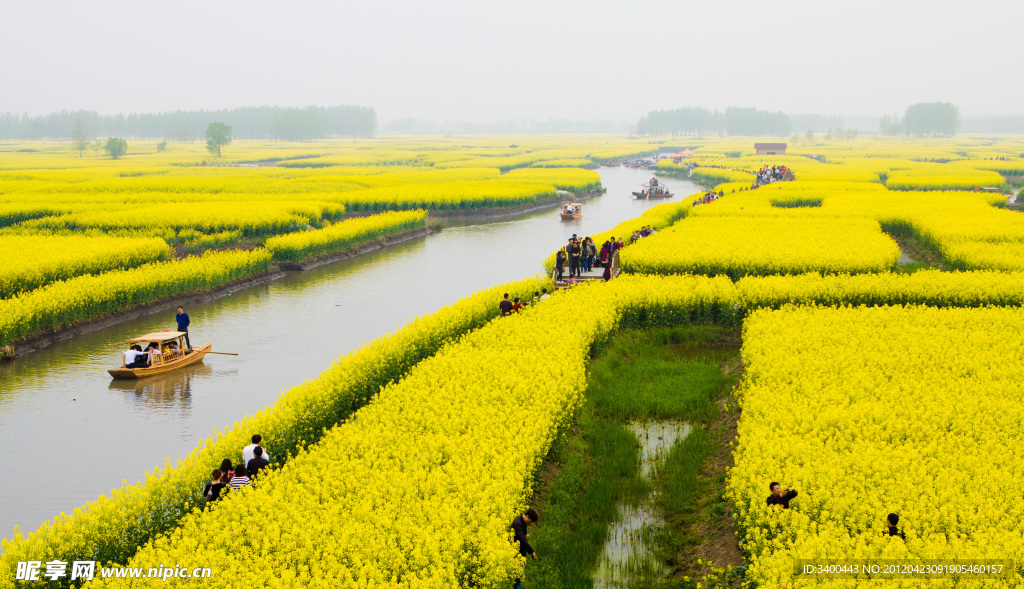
[265,211,427,261]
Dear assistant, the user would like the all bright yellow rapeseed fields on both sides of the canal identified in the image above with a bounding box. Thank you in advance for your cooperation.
[6,131,1024,588]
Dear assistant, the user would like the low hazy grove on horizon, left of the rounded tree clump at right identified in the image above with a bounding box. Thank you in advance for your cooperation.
[636,107,793,135]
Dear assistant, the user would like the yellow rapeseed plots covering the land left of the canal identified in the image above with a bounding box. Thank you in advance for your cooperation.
[0,138,622,353]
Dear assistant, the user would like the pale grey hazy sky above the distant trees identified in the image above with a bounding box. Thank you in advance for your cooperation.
[0,0,1024,122]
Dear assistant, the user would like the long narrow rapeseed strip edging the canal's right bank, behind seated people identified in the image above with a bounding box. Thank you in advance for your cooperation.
[0,279,550,586]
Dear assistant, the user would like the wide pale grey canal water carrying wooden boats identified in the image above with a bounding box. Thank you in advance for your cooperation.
[0,168,699,538]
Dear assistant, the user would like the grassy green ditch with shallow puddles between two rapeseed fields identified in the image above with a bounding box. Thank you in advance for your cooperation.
[523,326,743,589]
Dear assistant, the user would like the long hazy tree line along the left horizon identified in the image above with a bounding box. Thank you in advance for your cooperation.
[0,106,377,142]
